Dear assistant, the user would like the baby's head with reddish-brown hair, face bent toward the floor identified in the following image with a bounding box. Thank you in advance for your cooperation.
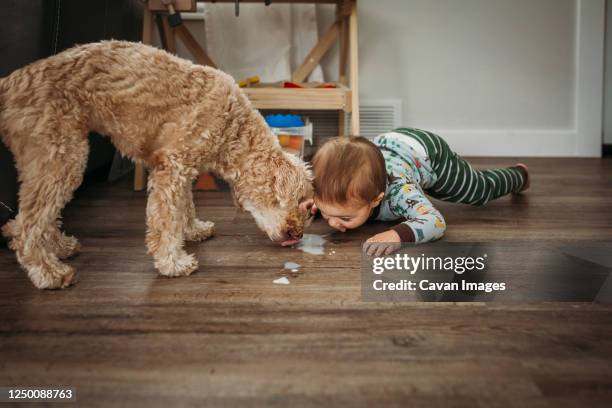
[312,137,387,232]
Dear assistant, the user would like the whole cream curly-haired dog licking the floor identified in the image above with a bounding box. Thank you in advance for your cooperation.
[0,41,312,288]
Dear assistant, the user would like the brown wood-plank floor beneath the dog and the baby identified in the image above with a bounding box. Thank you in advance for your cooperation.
[0,159,612,407]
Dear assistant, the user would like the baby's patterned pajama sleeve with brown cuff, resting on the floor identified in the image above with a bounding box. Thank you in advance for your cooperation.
[382,180,446,244]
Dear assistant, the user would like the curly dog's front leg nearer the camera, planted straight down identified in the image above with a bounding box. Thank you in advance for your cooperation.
[147,158,198,276]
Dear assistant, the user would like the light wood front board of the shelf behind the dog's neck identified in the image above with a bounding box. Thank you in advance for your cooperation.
[242,84,352,112]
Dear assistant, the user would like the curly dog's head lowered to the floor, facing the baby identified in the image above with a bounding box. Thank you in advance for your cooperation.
[236,152,313,244]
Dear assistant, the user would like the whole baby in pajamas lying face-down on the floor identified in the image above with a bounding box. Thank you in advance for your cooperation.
[304,128,529,256]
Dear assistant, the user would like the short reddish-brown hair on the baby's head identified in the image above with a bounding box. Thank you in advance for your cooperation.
[312,136,387,205]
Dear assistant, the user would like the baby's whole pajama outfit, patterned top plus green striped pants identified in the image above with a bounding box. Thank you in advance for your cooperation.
[370,128,526,244]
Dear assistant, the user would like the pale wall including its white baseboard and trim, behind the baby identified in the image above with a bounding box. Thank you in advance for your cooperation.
[184,0,612,156]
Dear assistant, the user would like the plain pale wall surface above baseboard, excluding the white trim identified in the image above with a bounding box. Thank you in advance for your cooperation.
[359,0,575,129]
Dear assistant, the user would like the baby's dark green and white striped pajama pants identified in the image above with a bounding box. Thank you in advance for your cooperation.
[395,129,525,206]
